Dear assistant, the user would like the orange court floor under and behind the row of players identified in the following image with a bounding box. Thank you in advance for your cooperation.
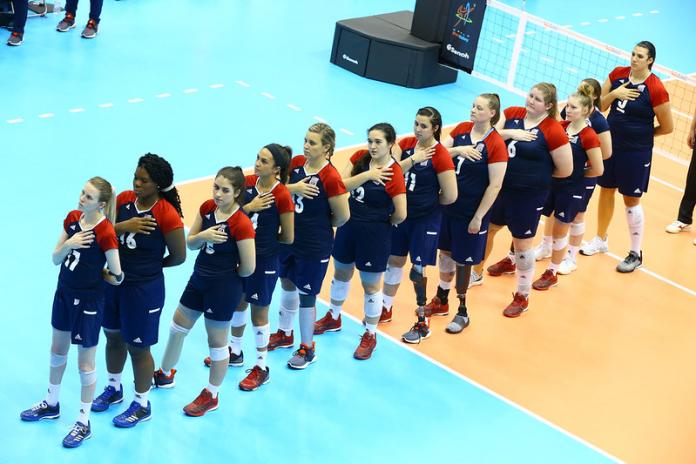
[180,123,696,463]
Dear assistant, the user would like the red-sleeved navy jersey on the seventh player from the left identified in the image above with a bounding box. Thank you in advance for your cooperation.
[399,136,454,220]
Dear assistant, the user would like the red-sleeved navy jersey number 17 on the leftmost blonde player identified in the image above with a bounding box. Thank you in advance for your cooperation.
[58,210,118,290]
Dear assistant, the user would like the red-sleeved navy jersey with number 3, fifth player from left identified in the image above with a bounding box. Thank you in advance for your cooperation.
[289,155,346,259]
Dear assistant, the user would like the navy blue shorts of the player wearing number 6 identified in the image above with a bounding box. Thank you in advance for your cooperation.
[491,190,549,238]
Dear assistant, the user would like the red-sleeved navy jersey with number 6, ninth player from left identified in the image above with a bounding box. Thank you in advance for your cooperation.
[503,106,568,191]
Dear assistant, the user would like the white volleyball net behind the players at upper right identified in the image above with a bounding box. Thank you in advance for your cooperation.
[472,0,696,164]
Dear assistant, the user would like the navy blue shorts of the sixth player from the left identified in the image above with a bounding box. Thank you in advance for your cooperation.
[331,220,392,272]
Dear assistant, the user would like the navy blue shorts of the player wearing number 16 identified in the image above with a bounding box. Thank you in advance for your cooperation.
[102,276,164,347]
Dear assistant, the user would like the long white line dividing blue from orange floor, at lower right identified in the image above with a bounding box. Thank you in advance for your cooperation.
[317,298,622,463]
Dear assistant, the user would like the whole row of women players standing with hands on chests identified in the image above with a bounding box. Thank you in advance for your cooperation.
[21,42,672,447]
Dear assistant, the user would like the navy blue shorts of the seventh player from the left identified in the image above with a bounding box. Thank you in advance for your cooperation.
[391,209,442,266]
